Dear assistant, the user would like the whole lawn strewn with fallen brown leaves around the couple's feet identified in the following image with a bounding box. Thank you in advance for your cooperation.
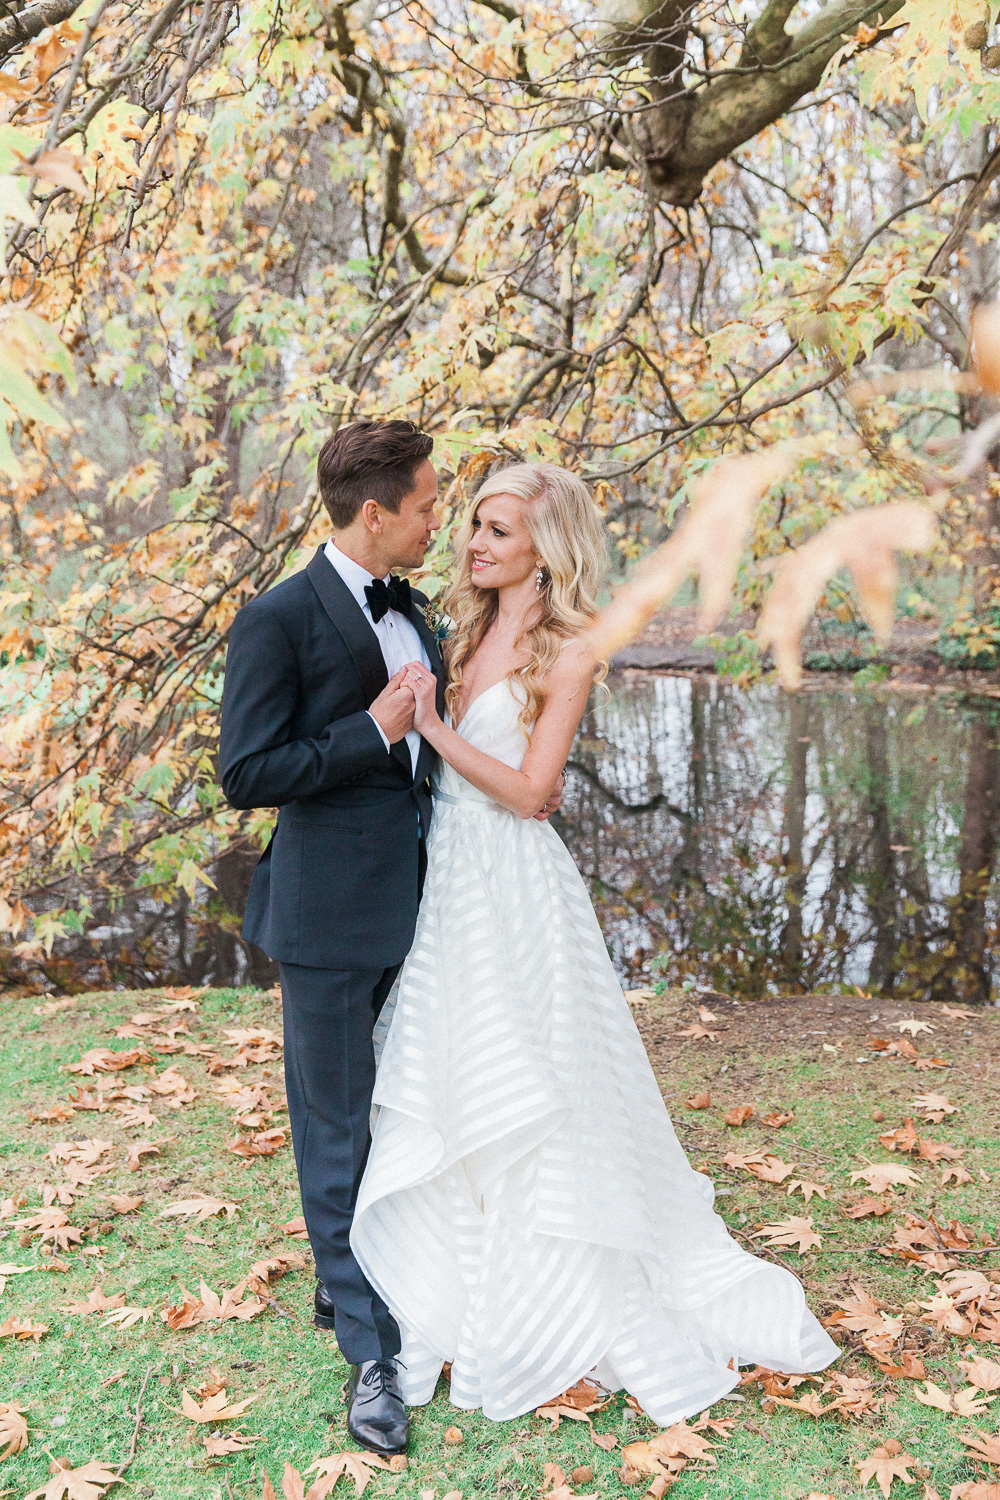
[0,990,1000,1500]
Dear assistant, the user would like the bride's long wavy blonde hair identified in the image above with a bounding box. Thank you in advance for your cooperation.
[442,464,607,729]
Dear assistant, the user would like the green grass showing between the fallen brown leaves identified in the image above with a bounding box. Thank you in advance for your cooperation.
[0,990,1000,1500]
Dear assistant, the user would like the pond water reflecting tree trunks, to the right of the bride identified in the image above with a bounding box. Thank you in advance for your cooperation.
[561,674,1000,1001]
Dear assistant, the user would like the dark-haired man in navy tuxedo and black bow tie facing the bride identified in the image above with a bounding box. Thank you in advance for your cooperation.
[220,422,445,1454]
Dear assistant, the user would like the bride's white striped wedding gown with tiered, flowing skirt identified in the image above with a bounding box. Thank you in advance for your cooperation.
[351,681,838,1425]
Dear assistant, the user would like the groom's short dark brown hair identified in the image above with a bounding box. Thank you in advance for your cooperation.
[318,417,433,531]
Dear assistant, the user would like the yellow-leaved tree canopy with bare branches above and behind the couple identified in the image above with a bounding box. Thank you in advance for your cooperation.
[0,0,1000,966]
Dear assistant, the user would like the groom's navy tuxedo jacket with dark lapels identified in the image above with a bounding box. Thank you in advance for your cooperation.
[220,549,444,969]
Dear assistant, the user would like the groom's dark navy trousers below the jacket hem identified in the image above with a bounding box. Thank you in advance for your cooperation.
[280,963,399,1365]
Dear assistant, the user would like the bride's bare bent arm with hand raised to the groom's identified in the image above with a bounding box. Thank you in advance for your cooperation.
[406,645,594,818]
